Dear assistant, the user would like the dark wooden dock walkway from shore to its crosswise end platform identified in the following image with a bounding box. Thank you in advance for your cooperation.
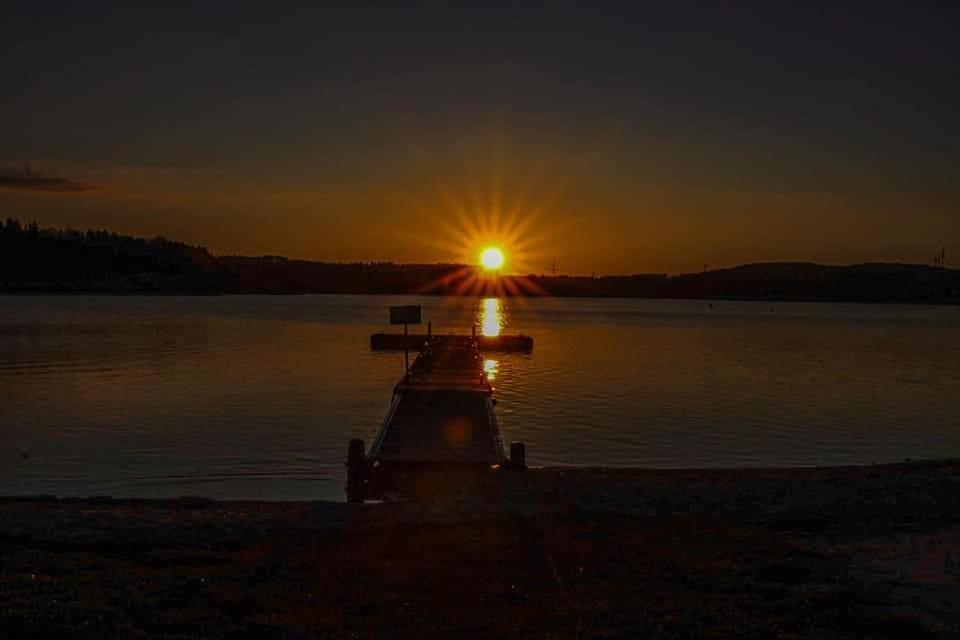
[347,335,525,501]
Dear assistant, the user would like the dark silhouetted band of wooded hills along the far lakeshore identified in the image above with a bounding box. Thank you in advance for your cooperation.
[0,219,960,304]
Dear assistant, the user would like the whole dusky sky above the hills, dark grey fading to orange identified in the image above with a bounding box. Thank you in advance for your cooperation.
[0,0,960,274]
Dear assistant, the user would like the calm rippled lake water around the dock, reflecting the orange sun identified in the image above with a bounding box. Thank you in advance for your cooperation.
[0,296,960,499]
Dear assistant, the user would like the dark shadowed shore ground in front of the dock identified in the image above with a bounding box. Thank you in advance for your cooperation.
[0,462,960,638]
